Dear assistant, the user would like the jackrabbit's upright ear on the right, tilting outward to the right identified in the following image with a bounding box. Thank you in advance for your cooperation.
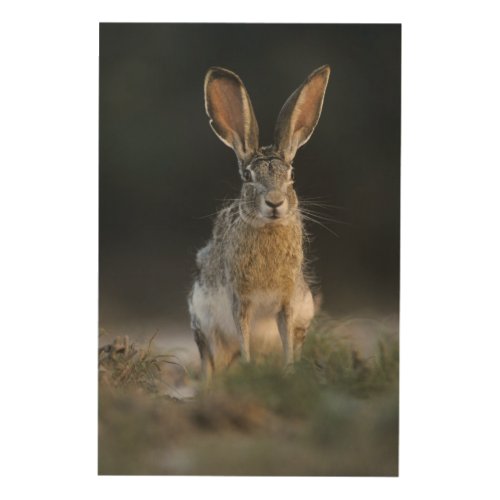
[274,65,330,161]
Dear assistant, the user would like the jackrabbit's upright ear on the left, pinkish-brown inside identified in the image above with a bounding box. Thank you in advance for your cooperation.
[205,68,259,162]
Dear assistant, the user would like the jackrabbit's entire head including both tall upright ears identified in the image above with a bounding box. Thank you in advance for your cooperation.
[205,66,330,223]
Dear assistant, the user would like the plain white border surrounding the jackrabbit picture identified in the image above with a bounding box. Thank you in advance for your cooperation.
[0,0,500,500]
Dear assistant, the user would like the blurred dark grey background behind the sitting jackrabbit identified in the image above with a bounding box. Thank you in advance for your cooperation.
[99,24,401,336]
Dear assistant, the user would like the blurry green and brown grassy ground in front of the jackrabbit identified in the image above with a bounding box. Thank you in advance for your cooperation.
[99,318,399,476]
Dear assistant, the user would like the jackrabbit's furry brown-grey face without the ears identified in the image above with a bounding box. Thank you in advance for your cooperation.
[240,153,298,224]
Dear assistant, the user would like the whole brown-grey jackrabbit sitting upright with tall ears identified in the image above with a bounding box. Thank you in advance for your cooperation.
[189,65,330,380]
